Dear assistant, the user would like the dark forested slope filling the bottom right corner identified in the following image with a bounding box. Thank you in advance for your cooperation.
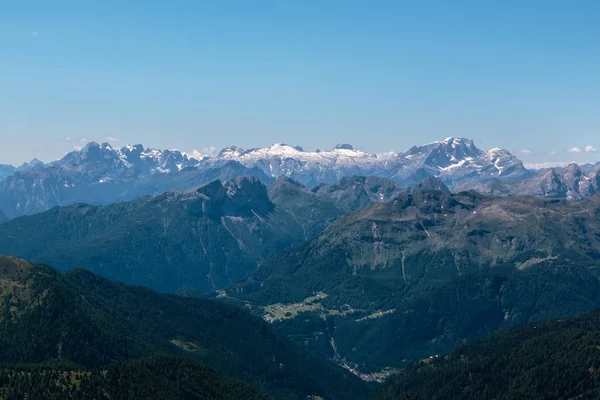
[373,312,600,400]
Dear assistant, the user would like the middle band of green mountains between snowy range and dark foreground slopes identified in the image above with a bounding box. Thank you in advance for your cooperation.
[0,142,600,398]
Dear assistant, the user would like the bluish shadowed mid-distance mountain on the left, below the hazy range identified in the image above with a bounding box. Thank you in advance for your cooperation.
[0,177,403,293]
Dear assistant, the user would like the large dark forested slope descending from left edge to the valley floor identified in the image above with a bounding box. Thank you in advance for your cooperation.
[0,256,366,399]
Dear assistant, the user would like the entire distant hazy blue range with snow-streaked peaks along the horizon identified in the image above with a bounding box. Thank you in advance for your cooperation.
[0,138,533,218]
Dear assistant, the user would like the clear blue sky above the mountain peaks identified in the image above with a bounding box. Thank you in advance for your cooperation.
[0,0,600,166]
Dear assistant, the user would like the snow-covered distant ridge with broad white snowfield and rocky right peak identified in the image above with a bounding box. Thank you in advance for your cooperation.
[206,137,528,186]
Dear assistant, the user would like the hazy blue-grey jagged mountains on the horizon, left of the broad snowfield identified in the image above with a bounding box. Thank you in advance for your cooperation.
[0,155,272,218]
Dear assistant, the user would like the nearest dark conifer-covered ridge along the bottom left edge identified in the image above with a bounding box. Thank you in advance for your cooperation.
[0,356,267,400]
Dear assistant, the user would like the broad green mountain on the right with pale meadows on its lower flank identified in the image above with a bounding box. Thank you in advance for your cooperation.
[228,178,600,372]
